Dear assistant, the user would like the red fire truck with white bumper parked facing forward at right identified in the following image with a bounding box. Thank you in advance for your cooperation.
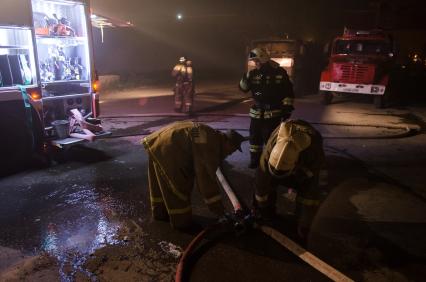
[319,29,394,108]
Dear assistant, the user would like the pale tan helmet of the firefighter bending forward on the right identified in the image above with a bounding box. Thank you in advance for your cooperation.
[268,122,311,175]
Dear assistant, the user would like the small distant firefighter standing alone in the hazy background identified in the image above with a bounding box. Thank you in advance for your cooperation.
[172,57,194,114]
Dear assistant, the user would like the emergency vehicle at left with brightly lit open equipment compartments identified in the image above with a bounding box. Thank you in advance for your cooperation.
[0,0,106,173]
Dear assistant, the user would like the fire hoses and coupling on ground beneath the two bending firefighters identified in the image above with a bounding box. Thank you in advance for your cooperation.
[175,168,353,282]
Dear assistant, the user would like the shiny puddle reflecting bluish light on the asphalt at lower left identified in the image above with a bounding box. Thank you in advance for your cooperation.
[40,184,122,281]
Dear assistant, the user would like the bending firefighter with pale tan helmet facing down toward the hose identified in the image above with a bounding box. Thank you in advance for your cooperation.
[254,120,325,238]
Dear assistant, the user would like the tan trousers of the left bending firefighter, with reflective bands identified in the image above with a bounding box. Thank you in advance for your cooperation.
[148,158,192,228]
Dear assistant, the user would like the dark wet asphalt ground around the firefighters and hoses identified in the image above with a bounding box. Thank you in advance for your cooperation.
[0,85,426,281]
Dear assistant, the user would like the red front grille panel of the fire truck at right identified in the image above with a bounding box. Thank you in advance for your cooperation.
[333,64,375,84]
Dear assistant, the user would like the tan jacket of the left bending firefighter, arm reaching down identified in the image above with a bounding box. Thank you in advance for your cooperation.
[142,121,229,214]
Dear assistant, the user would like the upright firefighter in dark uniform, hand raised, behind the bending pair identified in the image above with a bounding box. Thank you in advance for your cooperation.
[239,48,294,168]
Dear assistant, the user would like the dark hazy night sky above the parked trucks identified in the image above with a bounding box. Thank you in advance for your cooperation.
[92,0,426,76]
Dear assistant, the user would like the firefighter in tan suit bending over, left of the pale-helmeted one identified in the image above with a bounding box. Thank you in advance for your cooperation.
[142,121,244,229]
